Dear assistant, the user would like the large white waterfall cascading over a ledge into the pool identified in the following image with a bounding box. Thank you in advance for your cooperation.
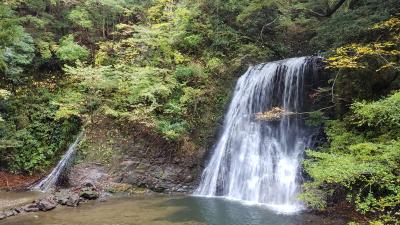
[194,57,312,213]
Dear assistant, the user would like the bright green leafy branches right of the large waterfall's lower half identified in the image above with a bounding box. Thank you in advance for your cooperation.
[303,92,400,223]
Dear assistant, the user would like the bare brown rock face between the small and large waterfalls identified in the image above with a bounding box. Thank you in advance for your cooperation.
[68,117,205,192]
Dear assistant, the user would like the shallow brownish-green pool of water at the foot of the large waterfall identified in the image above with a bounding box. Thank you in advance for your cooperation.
[0,196,346,225]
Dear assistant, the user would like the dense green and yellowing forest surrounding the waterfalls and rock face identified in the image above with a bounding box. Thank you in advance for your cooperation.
[0,0,400,224]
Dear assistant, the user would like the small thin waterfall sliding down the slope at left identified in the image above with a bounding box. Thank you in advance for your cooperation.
[31,131,83,192]
